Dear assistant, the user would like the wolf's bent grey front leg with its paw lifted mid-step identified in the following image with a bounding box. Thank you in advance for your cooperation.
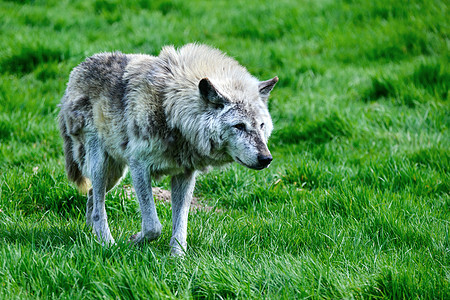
[130,159,162,243]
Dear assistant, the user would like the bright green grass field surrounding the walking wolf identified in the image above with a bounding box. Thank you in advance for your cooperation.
[0,0,450,299]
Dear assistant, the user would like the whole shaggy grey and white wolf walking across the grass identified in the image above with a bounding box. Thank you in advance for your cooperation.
[59,44,278,254]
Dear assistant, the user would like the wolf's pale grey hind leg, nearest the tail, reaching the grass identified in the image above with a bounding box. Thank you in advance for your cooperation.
[87,137,115,244]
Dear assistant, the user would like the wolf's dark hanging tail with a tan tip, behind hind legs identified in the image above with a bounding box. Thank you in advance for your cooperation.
[58,112,91,194]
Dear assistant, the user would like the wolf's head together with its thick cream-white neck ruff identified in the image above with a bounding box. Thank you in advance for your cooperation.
[158,44,278,170]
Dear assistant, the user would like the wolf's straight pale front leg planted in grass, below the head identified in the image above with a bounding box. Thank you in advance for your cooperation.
[170,171,196,256]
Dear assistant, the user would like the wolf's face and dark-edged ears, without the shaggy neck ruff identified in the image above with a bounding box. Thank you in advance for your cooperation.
[198,77,278,170]
